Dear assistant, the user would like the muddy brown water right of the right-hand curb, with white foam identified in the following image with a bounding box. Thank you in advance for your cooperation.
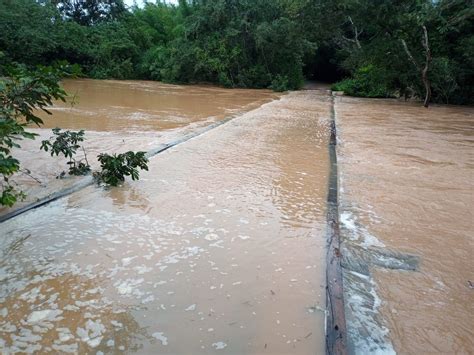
[336,97,474,354]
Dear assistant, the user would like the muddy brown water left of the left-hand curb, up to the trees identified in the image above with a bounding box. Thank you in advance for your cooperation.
[0,79,279,214]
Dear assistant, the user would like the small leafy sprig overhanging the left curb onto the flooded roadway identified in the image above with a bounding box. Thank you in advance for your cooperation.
[94,151,148,186]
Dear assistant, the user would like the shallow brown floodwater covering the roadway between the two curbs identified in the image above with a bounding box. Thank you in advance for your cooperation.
[0,88,330,354]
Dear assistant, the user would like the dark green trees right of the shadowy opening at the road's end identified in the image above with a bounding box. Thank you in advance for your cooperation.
[330,0,474,103]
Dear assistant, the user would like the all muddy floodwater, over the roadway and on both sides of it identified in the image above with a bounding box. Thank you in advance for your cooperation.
[0,80,474,354]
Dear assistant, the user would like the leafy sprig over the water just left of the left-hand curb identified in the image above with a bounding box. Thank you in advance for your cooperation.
[41,128,91,176]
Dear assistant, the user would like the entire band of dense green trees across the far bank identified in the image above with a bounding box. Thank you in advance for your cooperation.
[0,0,474,103]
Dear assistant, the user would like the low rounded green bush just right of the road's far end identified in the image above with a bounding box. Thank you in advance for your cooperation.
[331,65,393,97]
